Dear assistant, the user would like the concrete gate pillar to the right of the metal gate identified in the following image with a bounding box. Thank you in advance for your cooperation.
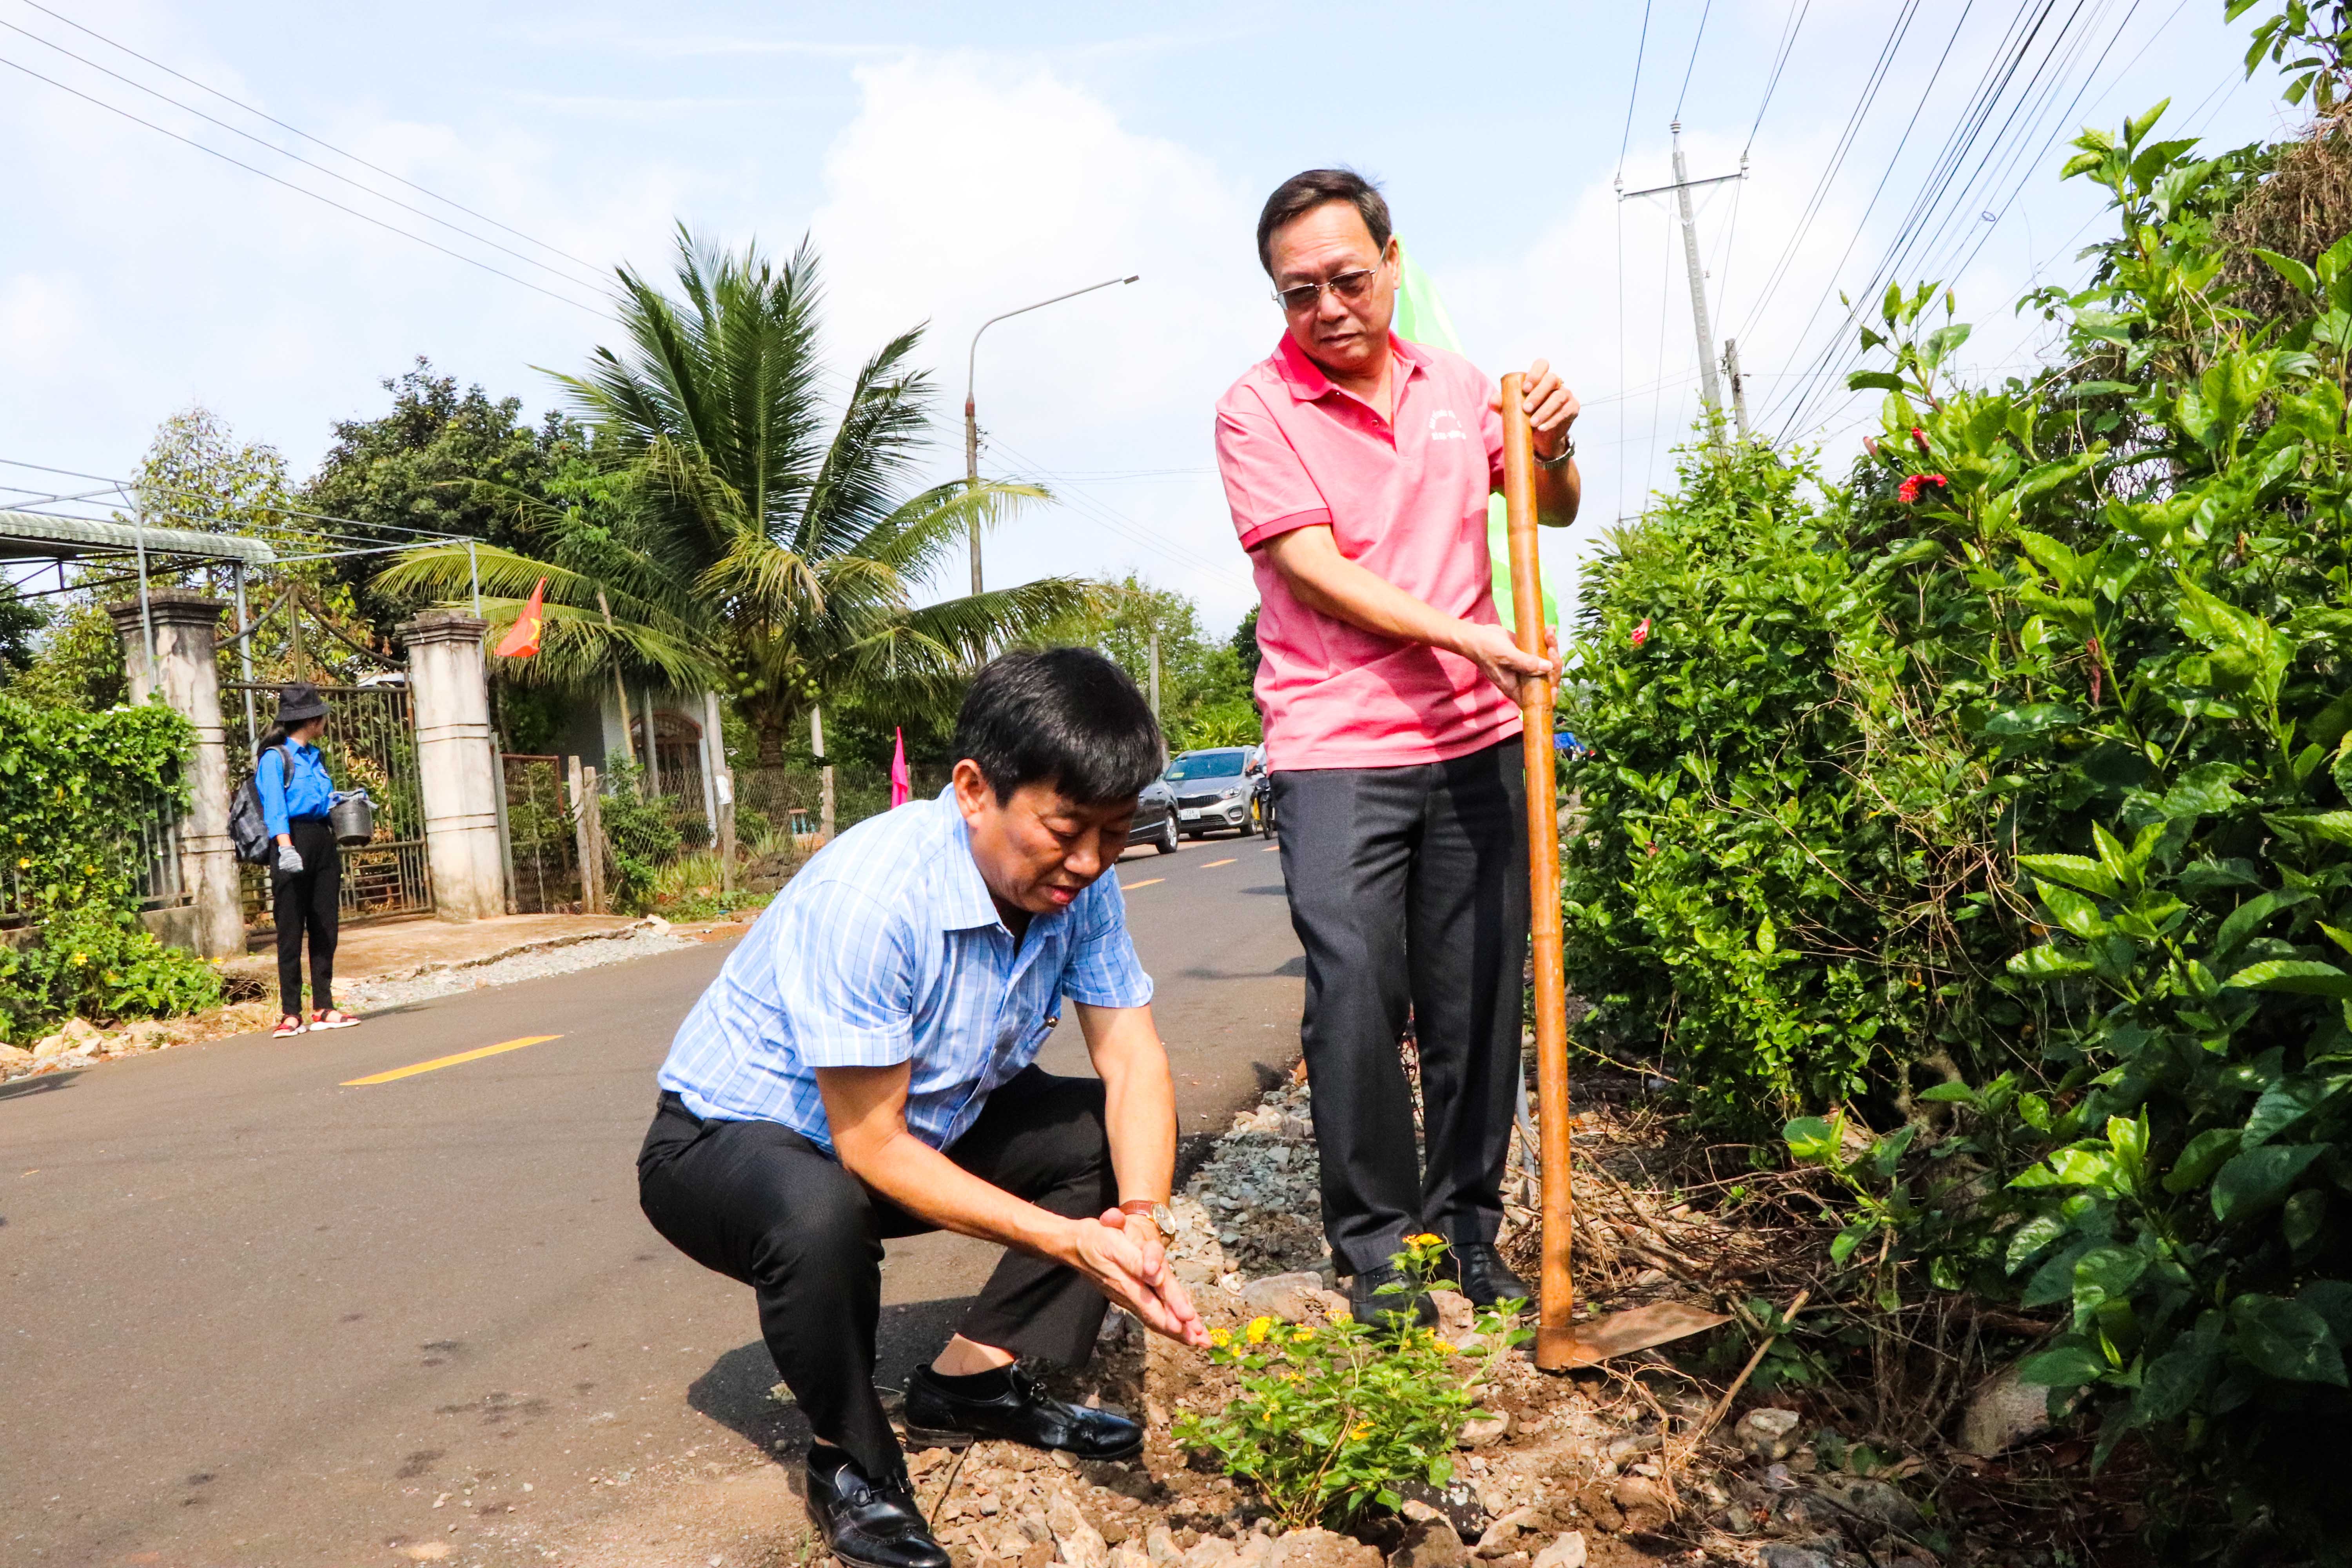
[400,609,506,919]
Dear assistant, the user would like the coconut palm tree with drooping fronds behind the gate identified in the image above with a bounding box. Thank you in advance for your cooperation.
[379,228,1089,766]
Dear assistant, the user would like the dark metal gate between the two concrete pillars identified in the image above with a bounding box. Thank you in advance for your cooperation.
[221,679,433,933]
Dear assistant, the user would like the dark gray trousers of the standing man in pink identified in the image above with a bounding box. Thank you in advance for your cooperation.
[1275,738,1526,1274]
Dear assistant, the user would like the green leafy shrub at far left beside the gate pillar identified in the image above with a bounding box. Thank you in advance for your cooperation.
[0,693,221,1044]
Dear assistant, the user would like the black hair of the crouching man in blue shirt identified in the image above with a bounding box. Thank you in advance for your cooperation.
[955,649,1167,806]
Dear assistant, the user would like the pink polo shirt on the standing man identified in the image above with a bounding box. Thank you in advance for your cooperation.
[1216,334,1519,769]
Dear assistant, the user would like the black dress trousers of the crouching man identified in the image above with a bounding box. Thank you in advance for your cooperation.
[637,1067,1120,1479]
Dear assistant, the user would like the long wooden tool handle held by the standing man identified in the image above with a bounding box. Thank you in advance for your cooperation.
[1503,372,1576,1368]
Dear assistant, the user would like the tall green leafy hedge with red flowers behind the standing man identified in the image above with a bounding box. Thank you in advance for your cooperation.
[1566,80,2352,1549]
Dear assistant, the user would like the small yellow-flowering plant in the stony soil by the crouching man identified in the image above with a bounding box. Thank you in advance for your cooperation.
[1176,1234,1526,1528]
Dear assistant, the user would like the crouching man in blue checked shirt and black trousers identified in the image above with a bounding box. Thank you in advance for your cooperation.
[637,649,1207,1568]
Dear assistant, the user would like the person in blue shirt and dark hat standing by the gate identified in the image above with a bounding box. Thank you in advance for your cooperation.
[254,682,360,1039]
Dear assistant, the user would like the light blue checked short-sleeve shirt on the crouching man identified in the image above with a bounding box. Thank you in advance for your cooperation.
[659,792,1152,1152]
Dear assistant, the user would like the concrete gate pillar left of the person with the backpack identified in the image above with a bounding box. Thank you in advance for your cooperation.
[106,588,245,959]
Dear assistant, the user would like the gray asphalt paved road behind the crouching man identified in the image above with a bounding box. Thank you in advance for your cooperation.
[0,839,1301,1568]
